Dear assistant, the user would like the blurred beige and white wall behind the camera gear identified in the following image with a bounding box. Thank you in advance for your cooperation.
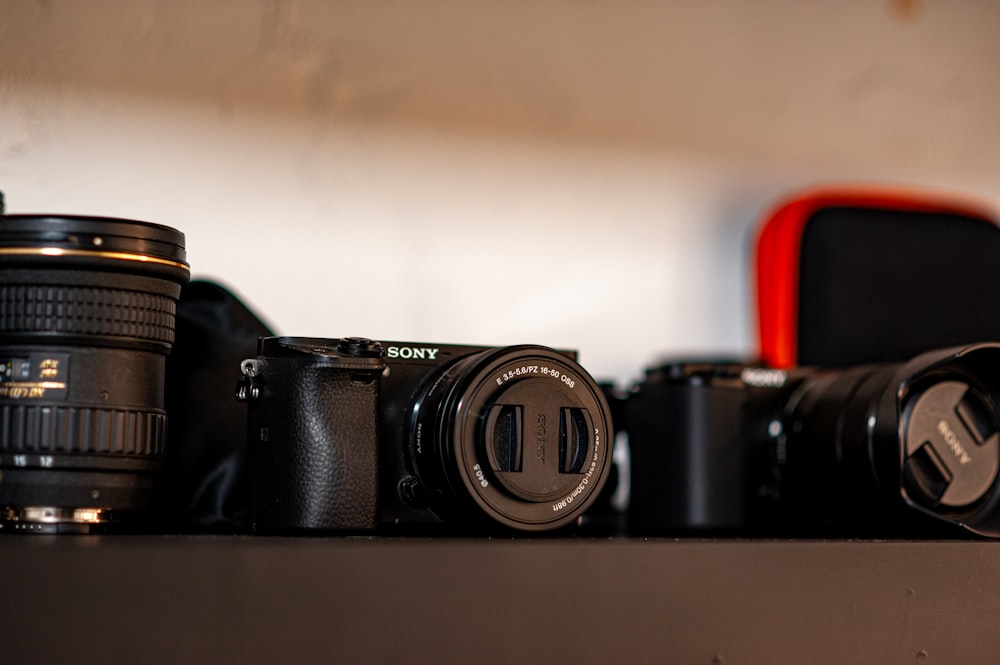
[0,0,1000,378]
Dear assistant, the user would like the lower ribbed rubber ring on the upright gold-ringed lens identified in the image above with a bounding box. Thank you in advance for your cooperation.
[0,404,167,456]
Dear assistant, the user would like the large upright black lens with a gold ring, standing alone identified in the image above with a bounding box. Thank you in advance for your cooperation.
[0,215,189,532]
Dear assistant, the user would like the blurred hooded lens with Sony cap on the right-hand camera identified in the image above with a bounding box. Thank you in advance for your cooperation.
[785,343,1000,536]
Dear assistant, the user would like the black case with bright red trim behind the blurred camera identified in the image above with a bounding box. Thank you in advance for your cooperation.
[755,188,1000,367]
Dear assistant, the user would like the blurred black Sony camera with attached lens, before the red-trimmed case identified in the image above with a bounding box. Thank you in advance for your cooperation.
[623,343,1000,537]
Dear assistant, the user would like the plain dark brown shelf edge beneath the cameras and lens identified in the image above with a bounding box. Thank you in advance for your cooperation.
[0,535,1000,665]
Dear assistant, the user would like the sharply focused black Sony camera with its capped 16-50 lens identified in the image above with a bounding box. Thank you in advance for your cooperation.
[239,337,613,532]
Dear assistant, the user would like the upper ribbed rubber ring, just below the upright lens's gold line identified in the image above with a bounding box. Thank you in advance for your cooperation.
[0,285,177,344]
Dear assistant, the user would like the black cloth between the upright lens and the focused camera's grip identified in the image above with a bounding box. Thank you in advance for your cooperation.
[155,280,273,532]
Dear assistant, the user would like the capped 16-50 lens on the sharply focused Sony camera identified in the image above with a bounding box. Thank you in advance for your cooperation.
[411,346,612,531]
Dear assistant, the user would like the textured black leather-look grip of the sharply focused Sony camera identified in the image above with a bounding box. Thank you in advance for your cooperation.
[247,358,379,532]
